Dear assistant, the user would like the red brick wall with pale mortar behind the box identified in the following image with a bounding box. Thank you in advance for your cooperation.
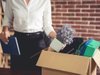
[51,0,100,40]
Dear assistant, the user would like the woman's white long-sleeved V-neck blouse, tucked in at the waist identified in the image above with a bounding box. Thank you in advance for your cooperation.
[3,0,54,35]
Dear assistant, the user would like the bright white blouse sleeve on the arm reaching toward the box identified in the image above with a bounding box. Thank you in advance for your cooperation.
[43,0,54,35]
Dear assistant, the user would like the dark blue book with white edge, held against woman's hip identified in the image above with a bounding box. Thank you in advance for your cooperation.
[0,36,21,55]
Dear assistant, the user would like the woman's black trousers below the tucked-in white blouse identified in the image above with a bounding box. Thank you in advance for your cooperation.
[11,31,45,75]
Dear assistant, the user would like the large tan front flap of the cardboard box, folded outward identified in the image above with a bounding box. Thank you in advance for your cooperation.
[37,51,90,74]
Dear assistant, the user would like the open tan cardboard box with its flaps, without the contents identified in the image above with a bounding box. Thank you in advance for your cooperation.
[37,50,100,75]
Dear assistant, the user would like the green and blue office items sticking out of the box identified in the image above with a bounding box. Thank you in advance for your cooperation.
[76,39,100,57]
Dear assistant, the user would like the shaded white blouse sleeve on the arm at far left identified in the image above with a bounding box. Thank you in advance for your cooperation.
[2,0,13,26]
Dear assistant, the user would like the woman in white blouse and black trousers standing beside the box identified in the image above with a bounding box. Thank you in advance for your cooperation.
[0,0,56,75]
